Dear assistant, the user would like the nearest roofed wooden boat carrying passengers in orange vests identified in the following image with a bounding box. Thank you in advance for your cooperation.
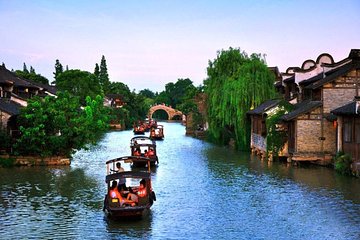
[103,156,156,220]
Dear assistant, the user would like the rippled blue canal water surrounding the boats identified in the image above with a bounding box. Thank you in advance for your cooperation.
[0,122,360,240]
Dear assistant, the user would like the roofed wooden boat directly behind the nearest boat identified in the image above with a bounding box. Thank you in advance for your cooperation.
[130,136,159,167]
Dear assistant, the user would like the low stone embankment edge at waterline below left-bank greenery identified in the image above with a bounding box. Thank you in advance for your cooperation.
[0,155,71,167]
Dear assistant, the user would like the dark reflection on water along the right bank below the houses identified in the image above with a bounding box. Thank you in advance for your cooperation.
[205,147,360,204]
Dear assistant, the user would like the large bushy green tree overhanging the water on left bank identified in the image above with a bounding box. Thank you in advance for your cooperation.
[14,92,108,156]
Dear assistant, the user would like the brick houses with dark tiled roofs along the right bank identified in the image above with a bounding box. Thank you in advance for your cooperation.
[248,49,360,164]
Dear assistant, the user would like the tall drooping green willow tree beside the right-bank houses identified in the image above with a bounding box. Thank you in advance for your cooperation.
[204,48,276,150]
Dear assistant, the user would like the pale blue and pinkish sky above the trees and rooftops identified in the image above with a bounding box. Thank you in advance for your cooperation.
[0,0,360,92]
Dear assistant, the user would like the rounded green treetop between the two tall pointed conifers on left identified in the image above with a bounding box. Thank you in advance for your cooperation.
[56,69,103,104]
